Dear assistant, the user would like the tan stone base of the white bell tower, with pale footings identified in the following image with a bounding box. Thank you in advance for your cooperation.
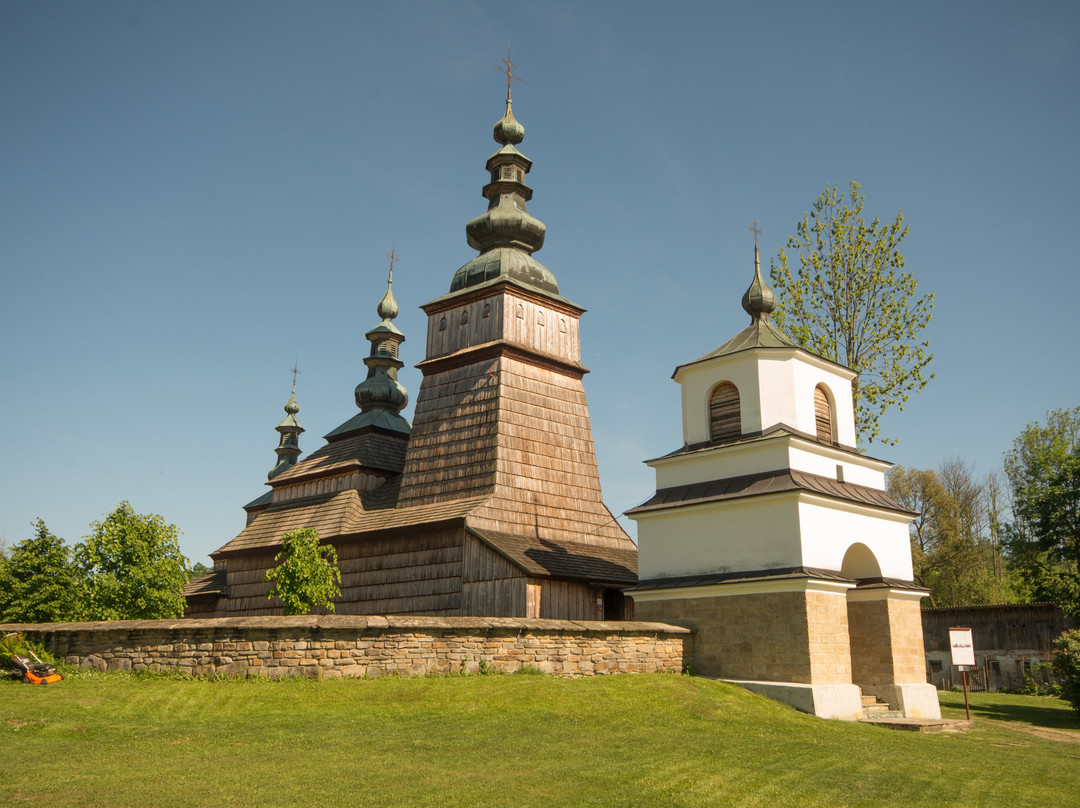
[633,577,940,721]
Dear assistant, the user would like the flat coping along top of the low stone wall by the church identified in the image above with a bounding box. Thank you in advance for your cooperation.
[0,615,691,634]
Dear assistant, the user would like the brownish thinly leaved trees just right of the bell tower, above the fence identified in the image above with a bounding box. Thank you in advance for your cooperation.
[889,460,1005,606]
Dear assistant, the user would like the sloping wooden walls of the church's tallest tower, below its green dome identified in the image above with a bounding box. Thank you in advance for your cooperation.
[399,276,634,548]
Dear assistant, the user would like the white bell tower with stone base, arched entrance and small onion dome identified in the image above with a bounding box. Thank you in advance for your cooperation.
[629,238,940,718]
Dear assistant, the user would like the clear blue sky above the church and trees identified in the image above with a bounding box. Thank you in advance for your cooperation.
[0,0,1080,561]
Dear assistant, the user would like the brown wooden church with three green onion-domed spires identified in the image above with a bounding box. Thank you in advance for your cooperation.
[186,80,637,620]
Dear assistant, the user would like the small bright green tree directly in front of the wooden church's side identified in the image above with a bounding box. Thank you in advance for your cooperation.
[267,527,341,615]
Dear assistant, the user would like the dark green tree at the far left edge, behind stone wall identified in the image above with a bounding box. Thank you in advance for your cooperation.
[0,519,82,623]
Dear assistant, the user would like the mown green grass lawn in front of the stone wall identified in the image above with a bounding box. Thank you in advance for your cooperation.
[0,674,1080,808]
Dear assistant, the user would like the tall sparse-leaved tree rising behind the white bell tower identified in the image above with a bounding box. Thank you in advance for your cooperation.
[770,181,934,443]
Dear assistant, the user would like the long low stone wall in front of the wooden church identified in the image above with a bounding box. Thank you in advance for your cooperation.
[6,615,690,678]
